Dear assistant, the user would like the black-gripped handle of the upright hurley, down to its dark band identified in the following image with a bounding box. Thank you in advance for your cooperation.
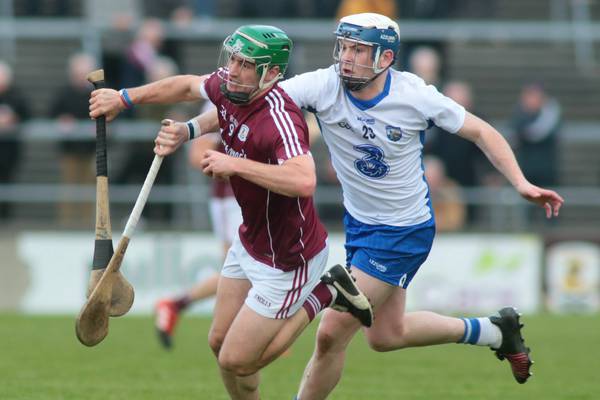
[87,69,114,269]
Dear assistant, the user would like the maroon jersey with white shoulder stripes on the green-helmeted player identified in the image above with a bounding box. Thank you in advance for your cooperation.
[204,73,327,271]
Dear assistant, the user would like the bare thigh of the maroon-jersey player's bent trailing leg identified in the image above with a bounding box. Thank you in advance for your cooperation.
[219,305,286,367]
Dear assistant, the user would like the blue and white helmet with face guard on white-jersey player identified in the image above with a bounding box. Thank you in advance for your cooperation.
[333,13,400,90]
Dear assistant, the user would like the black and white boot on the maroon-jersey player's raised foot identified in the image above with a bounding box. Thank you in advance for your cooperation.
[321,264,373,327]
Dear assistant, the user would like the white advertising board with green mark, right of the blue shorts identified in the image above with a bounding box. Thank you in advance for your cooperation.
[407,234,543,315]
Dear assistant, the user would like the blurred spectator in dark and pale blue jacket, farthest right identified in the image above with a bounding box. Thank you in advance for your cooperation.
[511,83,562,186]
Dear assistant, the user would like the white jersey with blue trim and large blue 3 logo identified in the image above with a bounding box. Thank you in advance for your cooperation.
[280,65,465,226]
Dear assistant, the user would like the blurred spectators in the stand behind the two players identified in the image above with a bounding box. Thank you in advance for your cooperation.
[0,0,562,231]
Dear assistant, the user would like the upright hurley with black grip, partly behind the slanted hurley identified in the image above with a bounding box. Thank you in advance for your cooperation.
[87,69,134,317]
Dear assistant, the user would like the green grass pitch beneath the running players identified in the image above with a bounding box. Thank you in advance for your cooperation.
[0,314,600,400]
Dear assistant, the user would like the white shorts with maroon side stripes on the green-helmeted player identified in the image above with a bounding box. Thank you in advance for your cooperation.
[221,236,329,319]
